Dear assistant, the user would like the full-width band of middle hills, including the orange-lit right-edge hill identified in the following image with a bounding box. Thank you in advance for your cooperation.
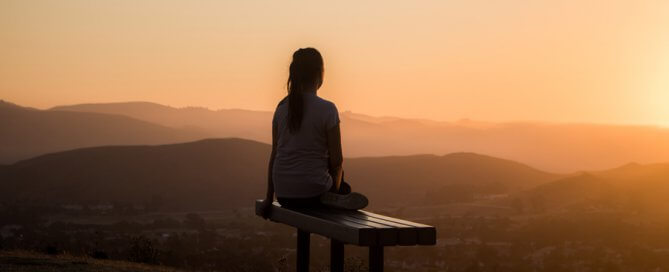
[0,138,669,214]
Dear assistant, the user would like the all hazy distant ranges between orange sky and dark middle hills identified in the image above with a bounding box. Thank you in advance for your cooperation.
[0,102,669,173]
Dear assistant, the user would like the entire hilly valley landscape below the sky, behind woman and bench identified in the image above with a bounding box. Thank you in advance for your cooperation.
[0,100,669,271]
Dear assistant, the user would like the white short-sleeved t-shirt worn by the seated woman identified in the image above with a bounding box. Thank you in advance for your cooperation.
[272,93,339,198]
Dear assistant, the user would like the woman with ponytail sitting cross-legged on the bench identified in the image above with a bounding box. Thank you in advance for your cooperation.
[262,48,368,217]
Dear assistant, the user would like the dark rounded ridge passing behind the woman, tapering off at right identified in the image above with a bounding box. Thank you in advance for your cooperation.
[0,139,558,209]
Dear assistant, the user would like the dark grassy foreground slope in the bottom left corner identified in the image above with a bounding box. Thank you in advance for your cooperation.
[0,250,183,272]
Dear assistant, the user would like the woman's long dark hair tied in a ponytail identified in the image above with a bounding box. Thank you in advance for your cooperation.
[286,47,323,133]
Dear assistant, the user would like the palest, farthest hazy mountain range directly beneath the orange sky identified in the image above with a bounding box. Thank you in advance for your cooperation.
[54,102,669,172]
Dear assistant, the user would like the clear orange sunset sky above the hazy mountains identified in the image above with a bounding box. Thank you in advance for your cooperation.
[0,0,669,126]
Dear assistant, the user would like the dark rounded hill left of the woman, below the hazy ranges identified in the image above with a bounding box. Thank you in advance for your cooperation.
[2,139,269,209]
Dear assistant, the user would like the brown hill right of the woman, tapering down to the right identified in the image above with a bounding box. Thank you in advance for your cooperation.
[344,153,560,203]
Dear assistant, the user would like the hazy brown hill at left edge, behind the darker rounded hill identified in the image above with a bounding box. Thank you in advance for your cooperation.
[0,101,205,164]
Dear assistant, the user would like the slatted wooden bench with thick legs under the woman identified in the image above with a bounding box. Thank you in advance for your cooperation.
[256,200,437,272]
